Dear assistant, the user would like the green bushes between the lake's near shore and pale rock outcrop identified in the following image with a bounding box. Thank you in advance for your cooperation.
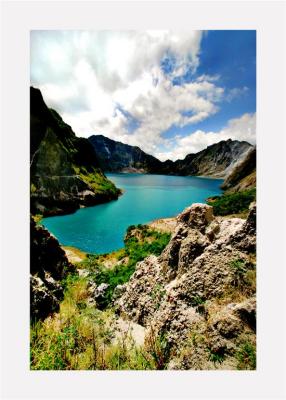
[78,225,171,309]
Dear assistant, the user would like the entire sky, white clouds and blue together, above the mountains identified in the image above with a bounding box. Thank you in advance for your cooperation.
[31,31,256,160]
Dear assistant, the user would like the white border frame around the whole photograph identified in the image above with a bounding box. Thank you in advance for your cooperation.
[0,1,286,399]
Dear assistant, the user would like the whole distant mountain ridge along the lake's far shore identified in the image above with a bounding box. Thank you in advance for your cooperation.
[88,135,252,178]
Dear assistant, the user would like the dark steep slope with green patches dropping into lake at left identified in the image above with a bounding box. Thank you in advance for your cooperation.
[30,87,120,215]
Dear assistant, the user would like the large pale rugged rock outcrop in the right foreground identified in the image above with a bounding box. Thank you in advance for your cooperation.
[116,204,256,369]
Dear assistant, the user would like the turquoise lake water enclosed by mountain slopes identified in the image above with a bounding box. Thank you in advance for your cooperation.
[43,174,222,253]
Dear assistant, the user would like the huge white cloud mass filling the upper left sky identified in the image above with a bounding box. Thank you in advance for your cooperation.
[31,30,255,158]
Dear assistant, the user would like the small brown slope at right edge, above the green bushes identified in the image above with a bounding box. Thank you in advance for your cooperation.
[221,148,256,193]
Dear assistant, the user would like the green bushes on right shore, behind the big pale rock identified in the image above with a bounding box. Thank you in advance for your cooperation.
[207,189,256,215]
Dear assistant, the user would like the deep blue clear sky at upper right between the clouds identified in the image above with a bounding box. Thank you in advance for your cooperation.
[155,30,256,138]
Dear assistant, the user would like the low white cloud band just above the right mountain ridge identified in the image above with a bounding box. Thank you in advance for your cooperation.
[155,113,256,161]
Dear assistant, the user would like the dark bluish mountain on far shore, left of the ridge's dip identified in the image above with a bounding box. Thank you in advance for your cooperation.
[88,135,161,173]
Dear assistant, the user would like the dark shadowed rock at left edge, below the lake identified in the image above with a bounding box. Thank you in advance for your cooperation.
[30,218,74,320]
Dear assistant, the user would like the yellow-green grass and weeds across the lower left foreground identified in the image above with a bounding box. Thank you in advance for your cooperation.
[30,275,173,370]
